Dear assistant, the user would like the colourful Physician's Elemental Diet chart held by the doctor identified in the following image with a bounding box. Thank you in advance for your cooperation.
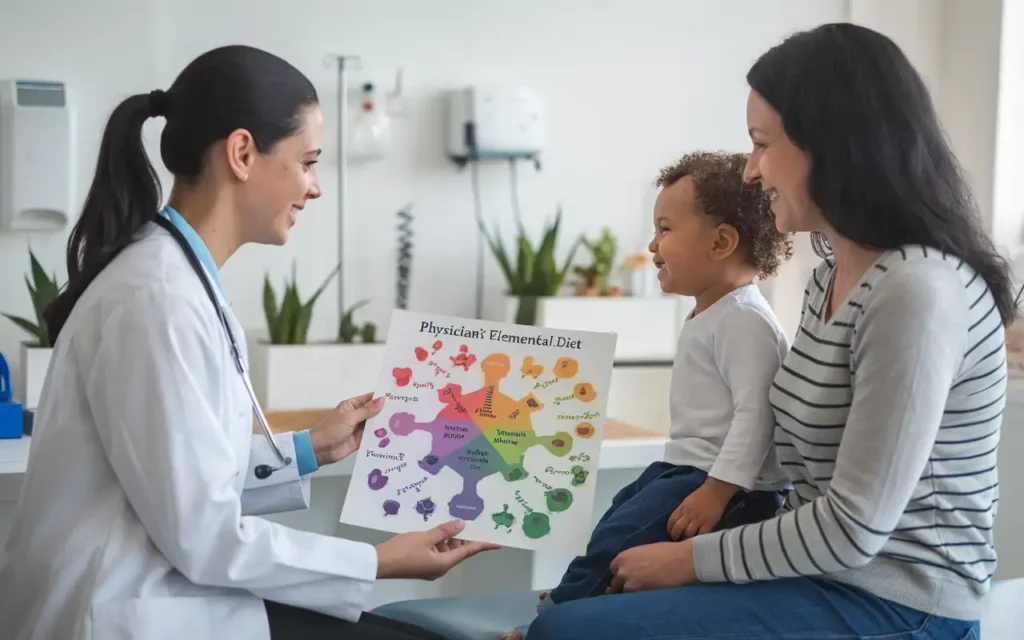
[341,310,615,554]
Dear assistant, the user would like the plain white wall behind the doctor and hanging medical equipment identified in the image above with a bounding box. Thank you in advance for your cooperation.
[0,0,843,374]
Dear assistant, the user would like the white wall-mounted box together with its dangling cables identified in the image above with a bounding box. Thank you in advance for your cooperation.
[445,86,544,318]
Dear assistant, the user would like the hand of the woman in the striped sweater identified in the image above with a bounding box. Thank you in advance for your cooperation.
[607,540,697,593]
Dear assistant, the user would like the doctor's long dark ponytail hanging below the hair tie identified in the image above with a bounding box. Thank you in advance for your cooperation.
[44,91,163,344]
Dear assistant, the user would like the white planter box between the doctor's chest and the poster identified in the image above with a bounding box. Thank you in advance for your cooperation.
[249,341,384,412]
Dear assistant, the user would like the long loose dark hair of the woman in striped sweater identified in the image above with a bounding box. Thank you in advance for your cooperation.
[746,23,1017,325]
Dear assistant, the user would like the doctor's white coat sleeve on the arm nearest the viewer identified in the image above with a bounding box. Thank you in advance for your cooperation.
[85,285,378,620]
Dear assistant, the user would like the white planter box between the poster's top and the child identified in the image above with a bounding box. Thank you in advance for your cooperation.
[486,296,693,362]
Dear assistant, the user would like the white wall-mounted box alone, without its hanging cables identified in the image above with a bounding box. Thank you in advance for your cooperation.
[446,86,544,165]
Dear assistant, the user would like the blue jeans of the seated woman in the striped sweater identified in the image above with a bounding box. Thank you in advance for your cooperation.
[527,578,980,640]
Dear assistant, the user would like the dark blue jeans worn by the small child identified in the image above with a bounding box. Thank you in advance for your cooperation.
[541,462,783,608]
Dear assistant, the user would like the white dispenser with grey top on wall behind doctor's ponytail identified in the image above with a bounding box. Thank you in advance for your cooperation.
[0,80,75,231]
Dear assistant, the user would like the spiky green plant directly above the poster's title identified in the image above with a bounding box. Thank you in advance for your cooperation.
[478,208,581,325]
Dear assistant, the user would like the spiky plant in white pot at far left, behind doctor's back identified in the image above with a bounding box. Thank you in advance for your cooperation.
[3,249,60,410]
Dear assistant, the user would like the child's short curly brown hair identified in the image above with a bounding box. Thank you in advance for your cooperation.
[656,152,793,280]
